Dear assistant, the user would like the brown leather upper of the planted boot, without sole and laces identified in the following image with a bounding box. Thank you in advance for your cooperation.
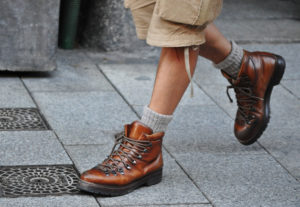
[80,121,164,186]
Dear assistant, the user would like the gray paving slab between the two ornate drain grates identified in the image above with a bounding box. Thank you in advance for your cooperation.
[0,131,72,166]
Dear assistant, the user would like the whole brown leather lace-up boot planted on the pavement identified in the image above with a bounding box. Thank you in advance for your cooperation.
[78,121,164,196]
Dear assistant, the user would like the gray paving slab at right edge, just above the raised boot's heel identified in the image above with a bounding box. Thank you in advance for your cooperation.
[215,18,300,43]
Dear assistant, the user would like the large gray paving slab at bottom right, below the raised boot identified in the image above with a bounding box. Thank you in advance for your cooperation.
[174,153,300,207]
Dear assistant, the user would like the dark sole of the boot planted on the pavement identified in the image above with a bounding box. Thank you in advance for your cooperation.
[77,169,162,196]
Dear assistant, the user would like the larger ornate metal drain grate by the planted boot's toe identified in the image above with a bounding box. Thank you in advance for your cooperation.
[0,165,79,197]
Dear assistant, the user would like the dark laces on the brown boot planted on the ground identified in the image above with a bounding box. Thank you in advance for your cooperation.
[95,132,152,176]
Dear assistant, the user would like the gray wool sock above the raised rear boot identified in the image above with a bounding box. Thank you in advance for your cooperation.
[214,41,244,78]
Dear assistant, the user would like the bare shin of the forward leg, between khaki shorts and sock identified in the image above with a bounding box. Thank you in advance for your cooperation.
[149,48,199,115]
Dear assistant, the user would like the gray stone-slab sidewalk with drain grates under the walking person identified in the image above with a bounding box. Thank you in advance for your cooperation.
[0,1,300,207]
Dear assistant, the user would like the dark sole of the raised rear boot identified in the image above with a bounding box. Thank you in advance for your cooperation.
[239,55,285,145]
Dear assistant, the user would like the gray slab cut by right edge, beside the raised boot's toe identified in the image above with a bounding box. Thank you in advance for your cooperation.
[259,126,300,181]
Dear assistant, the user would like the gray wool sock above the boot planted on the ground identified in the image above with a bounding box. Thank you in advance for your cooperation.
[141,106,173,133]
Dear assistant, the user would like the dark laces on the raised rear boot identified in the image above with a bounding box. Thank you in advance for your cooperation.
[226,76,264,124]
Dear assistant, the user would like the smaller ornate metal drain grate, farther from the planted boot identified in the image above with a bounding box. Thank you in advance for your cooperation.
[0,108,48,131]
